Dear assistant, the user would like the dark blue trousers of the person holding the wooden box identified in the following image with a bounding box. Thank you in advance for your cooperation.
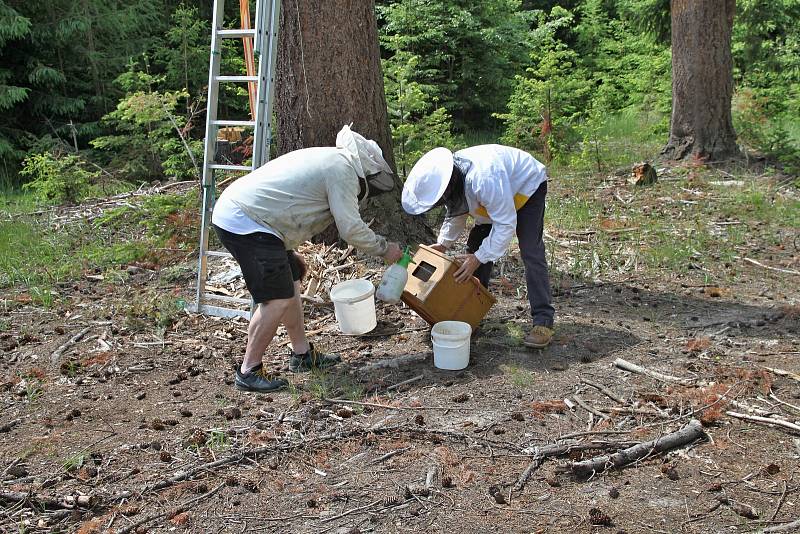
[467,182,555,328]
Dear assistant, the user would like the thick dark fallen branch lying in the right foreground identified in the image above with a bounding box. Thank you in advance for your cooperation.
[570,419,706,478]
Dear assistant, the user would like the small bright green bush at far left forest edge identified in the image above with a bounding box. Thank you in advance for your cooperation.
[20,152,99,204]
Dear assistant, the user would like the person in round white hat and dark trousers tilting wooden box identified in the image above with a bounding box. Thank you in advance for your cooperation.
[402,145,555,348]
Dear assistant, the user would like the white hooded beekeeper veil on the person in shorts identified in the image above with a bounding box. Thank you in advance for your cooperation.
[336,125,394,202]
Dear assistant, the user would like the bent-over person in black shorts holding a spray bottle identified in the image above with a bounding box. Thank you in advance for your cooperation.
[211,126,402,392]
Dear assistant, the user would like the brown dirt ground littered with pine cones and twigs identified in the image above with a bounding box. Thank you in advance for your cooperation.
[0,173,800,534]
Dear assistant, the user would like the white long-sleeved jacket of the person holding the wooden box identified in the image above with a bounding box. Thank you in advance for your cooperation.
[437,145,547,263]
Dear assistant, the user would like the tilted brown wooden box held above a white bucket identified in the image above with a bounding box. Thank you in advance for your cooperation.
[402,245,495,330]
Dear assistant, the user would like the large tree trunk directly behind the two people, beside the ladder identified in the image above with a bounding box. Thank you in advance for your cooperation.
[275,0,432,244]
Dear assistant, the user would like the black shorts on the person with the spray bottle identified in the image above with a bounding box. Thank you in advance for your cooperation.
[213,225,301,303]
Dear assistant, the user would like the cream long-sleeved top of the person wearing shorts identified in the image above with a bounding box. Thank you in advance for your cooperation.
[212,147,388,256]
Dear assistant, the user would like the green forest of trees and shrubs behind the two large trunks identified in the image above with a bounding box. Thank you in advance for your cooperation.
[0,0,800,203]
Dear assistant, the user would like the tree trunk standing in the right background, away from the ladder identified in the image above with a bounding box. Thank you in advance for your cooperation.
[662,0,739,161]
